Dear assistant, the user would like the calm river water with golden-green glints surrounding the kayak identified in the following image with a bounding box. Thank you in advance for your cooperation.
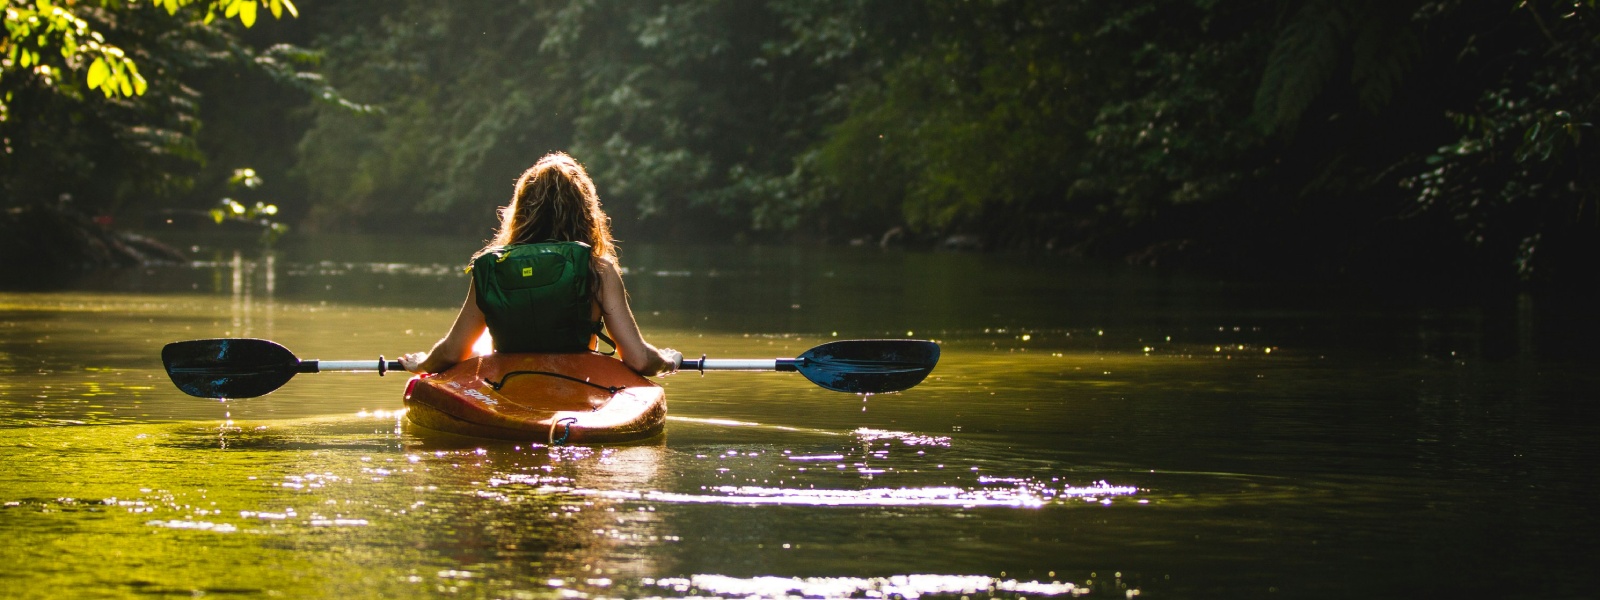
[0,235,1600,598]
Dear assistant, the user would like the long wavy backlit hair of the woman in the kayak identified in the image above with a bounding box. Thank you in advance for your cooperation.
[474,152,616,264]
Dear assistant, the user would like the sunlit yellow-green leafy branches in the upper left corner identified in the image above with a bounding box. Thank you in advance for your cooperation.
[0,0,337,214]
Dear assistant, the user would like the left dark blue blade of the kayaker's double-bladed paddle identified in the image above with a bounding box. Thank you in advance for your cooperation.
[162,339,299,398]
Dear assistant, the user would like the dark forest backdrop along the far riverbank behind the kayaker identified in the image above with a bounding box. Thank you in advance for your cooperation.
[0,0,1600,286]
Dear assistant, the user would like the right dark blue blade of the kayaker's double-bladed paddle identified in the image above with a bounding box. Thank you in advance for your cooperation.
[792,339,939,394]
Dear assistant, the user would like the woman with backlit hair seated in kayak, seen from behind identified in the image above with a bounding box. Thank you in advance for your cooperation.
[400,152,683,374]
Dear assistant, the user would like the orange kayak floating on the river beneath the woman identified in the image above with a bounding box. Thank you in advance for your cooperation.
[405,354,667,445]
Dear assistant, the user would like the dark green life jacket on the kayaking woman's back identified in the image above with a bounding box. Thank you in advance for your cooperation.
[472,242,603,352]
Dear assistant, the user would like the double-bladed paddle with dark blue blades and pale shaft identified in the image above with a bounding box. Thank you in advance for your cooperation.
[162,338,939,398]
